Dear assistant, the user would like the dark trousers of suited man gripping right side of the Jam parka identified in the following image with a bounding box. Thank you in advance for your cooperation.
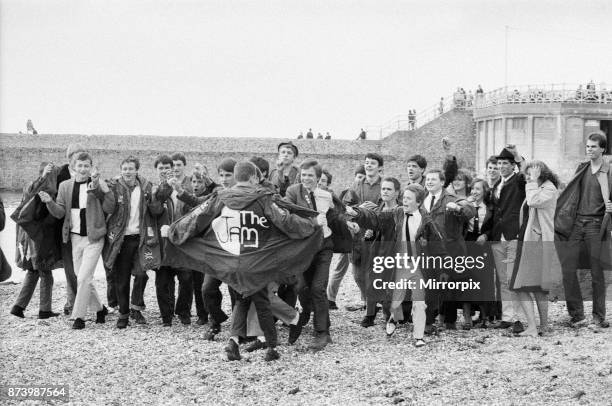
[299,242,333,333]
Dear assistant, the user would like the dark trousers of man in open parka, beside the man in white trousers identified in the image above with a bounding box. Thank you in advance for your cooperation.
[109,235,140,318]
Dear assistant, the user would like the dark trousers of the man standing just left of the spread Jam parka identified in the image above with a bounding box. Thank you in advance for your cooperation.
[155,266,193,321]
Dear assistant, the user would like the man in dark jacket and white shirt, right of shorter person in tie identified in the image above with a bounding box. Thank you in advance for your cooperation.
[423,169,476,333]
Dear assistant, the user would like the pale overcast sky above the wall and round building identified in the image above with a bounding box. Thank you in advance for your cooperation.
[0,0,612,138]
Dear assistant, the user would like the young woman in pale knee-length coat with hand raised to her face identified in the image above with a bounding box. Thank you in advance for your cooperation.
[510,161,559,337]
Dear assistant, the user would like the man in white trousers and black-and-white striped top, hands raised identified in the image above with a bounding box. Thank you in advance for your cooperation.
[39,152,115,329]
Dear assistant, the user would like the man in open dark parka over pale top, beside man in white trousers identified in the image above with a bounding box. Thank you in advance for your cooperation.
[102,156,163,329]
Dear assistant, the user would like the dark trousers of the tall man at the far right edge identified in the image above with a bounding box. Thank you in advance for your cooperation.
[557,217,606,320]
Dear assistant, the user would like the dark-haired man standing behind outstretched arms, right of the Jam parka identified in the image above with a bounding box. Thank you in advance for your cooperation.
[343,152,384,318]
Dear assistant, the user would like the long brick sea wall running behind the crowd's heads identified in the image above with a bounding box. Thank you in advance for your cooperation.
[0,112,475,192]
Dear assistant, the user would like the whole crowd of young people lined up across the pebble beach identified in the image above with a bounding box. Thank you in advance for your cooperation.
[3,133,612,361]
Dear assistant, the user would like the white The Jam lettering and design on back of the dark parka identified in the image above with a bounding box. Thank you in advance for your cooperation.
[212,206,270,255]
